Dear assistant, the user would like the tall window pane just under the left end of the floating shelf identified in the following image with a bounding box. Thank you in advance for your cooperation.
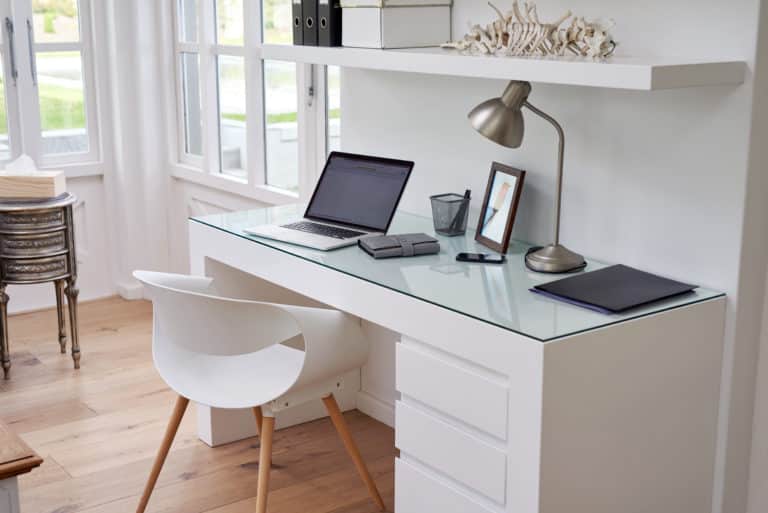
[264,61,299,192]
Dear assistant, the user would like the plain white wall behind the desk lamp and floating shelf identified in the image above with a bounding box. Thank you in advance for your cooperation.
[342,4,768,513]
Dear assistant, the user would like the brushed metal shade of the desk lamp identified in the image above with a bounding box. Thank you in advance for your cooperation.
[468,80,531,148]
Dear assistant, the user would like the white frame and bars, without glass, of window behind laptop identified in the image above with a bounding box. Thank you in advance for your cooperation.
[166,0,326,204]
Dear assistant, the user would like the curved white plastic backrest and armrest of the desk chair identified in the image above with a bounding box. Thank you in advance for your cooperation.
[134,271,368,404]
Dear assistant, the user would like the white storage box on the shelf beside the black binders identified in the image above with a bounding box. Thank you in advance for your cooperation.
[341,0,451,48]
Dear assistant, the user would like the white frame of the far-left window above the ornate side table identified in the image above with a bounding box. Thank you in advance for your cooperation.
[2,0,102,169]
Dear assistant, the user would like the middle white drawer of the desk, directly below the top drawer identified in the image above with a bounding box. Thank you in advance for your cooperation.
[395,401,507,504]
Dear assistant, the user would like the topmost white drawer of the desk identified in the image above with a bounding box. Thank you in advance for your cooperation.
[396,344,509,440]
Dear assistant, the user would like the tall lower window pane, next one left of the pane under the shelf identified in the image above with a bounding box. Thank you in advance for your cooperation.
[218,55,246,179]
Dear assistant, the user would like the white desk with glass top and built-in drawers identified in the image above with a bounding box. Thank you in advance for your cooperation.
[190,206,725,513]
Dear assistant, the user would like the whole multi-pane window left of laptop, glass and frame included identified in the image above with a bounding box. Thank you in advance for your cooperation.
[174,0,338,194]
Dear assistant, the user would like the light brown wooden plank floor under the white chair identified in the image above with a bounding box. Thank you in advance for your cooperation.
[0,298,394,513]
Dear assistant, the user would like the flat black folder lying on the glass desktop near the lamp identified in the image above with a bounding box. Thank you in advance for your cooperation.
[531,265,697,313]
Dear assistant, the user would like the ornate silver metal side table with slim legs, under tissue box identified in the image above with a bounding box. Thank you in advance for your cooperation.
[0,193,80,379]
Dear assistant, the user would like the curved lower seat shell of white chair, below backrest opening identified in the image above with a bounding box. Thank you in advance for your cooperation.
[153,343,304,408]
